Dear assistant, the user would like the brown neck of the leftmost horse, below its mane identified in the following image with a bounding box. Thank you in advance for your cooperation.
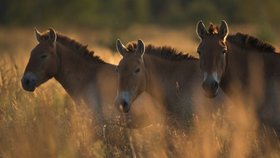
[54,43,106,101]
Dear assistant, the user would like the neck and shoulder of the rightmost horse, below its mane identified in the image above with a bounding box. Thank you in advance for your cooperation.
[224,42,280,88]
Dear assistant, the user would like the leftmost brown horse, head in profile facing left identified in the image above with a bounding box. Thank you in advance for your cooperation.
[22,29,117,123]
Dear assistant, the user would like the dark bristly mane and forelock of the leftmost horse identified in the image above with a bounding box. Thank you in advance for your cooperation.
[40,33,105,63]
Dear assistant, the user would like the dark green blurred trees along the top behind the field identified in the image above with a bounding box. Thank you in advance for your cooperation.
[0,0,280,27]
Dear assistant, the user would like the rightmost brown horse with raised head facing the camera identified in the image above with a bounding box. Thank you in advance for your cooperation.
[197,21,280,128]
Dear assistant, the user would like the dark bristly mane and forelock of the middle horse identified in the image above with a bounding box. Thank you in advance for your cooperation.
[126,42,196,61]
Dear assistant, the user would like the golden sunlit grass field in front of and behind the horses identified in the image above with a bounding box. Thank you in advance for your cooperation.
[0,26,280,158]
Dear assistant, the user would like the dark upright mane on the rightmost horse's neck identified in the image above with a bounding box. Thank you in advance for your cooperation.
[227,33,275,52]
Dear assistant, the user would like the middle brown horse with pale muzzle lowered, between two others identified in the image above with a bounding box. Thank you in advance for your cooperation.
[116,40,200,127]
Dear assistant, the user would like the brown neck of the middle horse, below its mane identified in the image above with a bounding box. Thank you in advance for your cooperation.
[144,55,199,100]
